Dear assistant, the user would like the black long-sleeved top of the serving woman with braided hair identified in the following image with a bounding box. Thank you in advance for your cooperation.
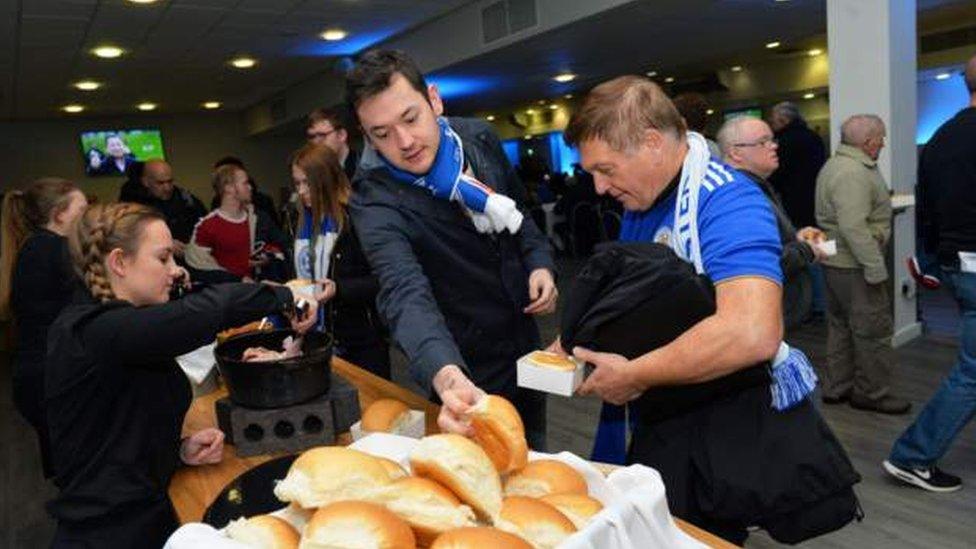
[46,284,292,524]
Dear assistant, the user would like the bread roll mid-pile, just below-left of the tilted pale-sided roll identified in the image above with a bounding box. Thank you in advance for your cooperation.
[379,477,476,546]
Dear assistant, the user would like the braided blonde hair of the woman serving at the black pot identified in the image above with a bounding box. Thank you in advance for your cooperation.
[68,203,164,302]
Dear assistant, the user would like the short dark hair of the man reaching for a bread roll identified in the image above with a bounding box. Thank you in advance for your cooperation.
[346,49,429,110]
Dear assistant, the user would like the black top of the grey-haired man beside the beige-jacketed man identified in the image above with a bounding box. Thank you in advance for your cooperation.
[769,120,827,227]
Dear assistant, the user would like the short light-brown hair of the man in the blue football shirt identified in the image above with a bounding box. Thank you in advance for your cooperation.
[565,76,687,151]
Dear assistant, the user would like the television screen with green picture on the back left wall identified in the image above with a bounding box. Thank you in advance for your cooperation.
[81,130,164,176]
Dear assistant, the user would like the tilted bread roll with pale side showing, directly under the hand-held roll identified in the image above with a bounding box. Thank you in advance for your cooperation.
[410,434,502,520]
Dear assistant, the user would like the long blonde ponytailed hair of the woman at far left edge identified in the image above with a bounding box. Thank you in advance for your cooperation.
[0,177,78,321]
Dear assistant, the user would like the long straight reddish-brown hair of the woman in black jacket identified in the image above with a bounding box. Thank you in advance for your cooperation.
[288,143,352,232]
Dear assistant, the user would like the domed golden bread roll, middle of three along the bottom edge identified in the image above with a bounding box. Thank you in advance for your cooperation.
[300,501,417,549]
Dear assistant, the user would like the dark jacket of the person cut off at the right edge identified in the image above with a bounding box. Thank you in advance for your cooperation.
[918,107,976,266]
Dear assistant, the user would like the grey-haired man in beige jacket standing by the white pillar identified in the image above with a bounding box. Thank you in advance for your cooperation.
[816,114,911,414]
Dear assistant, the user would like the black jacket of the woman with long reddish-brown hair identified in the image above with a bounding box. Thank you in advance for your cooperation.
[327,208,386,348]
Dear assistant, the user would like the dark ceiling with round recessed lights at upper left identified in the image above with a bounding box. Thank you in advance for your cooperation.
[0,0,471,119]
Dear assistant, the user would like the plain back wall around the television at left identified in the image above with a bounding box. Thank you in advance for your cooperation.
[0,113,304,205]
